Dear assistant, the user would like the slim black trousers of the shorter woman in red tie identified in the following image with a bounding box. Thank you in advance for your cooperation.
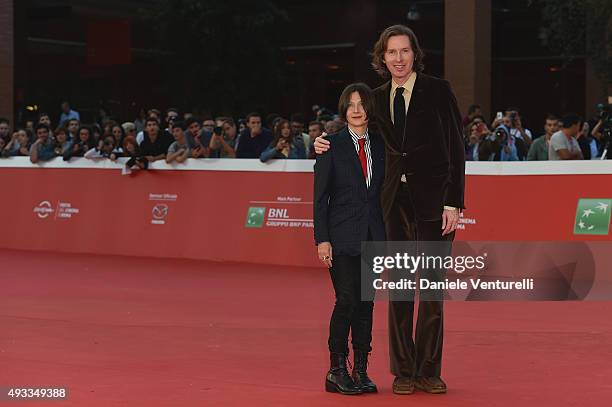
[328,255,374,354]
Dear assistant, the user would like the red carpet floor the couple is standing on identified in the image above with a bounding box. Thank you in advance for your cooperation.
[0,250,612,407]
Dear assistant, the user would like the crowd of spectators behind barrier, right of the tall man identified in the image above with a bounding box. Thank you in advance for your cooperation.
[463,105,609,161]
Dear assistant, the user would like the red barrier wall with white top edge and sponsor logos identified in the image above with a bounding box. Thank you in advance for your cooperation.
[0,158,612,266]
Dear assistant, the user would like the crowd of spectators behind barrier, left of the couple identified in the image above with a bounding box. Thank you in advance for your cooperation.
[0,102,334,169]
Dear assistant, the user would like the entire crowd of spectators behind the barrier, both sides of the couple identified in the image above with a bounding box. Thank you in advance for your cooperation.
[0,102,604,169]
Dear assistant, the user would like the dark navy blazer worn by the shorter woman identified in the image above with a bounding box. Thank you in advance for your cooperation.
[314,127,385,256]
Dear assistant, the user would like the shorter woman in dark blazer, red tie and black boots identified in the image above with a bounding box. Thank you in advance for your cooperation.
[314,83,385,394]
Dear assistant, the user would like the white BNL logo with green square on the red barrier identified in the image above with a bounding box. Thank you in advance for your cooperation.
[244,196,314,228]
